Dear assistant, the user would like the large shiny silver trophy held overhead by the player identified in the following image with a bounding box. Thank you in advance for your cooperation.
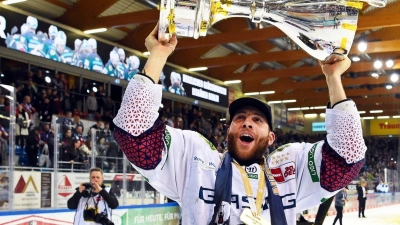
[158,0,387,60]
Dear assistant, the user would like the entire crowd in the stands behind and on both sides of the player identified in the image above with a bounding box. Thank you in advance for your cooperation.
[0,70,399,183]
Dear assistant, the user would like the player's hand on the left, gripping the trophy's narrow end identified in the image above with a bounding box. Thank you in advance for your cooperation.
[145,23,178,57]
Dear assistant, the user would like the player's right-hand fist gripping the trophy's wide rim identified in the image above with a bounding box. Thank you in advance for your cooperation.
[319,53,351,78]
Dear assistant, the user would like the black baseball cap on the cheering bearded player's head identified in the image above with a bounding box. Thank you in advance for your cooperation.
[229,97,274,131]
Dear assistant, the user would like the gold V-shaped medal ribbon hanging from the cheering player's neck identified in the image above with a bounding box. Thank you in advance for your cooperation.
[233,161,266,217]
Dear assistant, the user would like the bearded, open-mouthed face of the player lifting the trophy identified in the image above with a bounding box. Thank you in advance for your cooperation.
[228,106,275,160]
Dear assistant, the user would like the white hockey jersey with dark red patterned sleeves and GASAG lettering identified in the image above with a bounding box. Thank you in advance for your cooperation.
[114,74,366,225]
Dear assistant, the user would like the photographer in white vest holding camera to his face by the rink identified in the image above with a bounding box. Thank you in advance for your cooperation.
[67,168,118,225]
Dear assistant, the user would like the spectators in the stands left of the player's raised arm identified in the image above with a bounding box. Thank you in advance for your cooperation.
[0,70,122,171]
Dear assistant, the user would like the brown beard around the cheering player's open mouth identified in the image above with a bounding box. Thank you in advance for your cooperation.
[228,133,269,161]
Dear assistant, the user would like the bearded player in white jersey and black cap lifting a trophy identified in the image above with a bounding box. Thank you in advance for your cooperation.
[114,26,366,225]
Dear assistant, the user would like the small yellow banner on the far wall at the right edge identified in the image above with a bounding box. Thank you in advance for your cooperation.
[369,119,400,135]
